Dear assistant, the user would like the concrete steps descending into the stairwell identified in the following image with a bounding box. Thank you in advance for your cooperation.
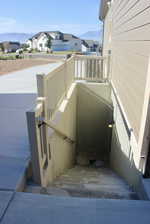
[25,166,138,200]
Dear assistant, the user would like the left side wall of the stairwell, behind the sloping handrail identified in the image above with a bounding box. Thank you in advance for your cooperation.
[48,85,77,181]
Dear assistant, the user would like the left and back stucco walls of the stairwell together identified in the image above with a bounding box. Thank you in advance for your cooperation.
[42,83,112,182]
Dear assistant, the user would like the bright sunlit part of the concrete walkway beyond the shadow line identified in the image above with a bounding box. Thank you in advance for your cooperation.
[0,62,62,93]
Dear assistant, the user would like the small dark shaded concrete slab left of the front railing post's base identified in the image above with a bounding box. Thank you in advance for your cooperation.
[0,156,28,191]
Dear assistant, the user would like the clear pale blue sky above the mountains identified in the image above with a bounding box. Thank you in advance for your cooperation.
[0,0,100,35]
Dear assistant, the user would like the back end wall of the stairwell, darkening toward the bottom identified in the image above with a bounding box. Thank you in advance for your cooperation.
[77,83,112,160]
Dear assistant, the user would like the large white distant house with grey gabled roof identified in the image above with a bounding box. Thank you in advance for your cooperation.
[27,31,82,51]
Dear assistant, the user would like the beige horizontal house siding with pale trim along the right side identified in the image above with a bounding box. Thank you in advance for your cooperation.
[103,0,150,172]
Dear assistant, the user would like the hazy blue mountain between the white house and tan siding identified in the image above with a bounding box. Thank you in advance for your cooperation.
[80,30,103,41]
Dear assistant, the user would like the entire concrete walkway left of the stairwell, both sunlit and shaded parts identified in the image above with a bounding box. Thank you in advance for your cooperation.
[0,63,60,191]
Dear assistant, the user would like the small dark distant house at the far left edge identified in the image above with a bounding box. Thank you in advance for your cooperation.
[1,41,20,53]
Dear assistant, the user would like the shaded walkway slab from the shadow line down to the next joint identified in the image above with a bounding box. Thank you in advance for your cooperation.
[0,94,36,158]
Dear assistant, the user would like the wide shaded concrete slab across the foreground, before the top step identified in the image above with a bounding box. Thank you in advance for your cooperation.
[2,193,150,224]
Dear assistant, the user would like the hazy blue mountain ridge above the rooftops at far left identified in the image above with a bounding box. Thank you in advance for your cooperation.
[0,33,34,43]
